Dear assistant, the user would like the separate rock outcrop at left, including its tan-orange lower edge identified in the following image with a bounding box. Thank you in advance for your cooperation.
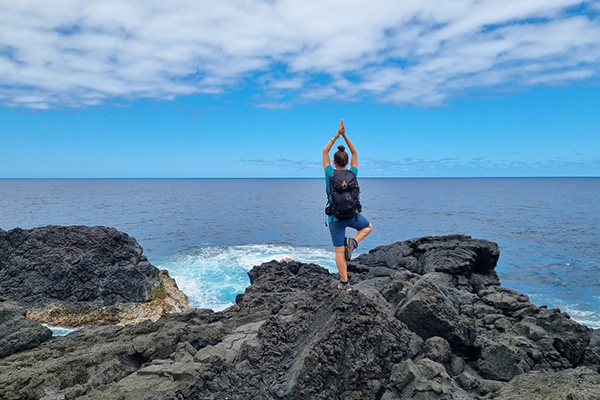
[0,226,189,326]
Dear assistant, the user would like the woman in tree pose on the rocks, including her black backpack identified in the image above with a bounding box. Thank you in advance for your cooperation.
[323,120,373,290]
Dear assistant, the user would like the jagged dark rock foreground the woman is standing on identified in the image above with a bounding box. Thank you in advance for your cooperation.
[0,235,600,400]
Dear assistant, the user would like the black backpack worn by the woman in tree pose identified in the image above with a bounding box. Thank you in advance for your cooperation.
[325,169,362,219]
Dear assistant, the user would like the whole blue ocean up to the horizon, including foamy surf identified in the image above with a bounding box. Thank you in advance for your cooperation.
[0,178,600,328]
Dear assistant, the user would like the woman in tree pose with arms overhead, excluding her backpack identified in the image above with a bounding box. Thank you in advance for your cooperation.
[323,120,373,290]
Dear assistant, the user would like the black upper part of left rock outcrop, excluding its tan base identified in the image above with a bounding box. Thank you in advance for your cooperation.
[0,226,160,309]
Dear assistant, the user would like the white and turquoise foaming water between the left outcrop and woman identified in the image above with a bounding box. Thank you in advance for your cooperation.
[158,244,337,311]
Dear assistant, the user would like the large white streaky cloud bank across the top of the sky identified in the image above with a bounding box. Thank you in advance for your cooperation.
[0,0,600,109]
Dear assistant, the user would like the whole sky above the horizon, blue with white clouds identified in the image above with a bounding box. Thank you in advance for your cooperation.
[0,0,600,178]
